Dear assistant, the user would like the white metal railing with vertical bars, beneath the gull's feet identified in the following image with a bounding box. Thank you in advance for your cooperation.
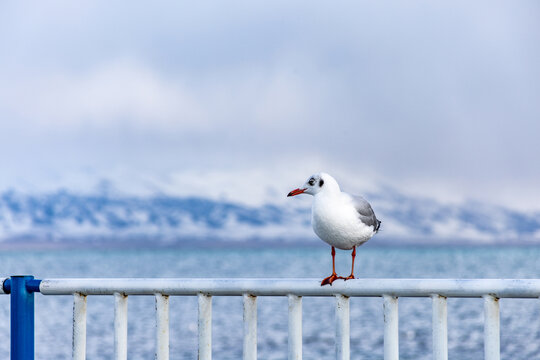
[5,279,540,360]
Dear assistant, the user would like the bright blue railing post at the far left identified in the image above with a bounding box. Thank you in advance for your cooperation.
[4,275,40,360]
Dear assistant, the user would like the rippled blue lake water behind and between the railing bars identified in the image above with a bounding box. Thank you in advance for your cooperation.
[0,244,540,360]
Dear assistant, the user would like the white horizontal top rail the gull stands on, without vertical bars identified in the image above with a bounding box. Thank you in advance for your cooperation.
[39,278,540,298]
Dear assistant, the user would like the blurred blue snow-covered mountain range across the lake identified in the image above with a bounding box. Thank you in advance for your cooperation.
[0,189,540,243]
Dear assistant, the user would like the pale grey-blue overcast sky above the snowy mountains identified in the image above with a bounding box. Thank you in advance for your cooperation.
[0,1,540,208]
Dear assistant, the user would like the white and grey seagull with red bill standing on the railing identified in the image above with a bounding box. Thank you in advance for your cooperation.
[287,172,381,286]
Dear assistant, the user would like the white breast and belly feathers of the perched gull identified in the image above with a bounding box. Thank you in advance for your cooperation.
[311,193,375,250]
